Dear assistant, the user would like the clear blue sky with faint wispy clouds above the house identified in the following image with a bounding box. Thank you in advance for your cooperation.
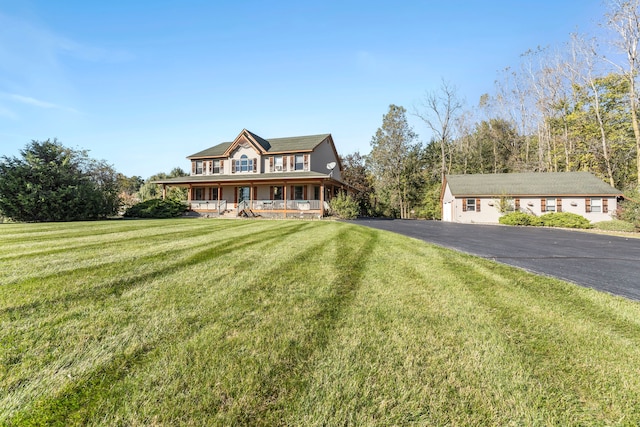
[0,0,604,178]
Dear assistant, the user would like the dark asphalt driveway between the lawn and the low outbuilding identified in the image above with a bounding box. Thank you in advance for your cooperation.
[353,219,640,301]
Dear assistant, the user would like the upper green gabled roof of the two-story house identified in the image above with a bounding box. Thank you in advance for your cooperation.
[187,129,331,159]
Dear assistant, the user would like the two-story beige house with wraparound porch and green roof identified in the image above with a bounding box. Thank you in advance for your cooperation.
[155,129,346,218]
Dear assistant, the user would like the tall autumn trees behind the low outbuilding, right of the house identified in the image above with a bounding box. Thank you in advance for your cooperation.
[342,0,640,218]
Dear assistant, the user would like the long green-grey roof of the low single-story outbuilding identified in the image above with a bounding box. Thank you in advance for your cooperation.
[445,172,622,197]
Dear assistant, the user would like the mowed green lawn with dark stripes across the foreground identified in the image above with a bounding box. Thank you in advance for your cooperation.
[0,219,640,426]
